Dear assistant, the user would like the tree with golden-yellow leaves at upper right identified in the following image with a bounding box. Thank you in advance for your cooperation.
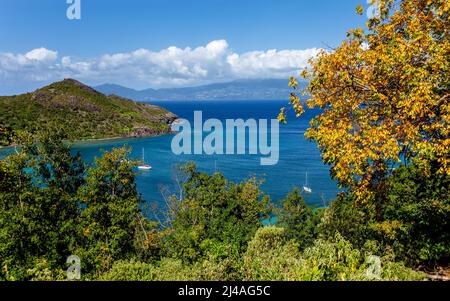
[279,0,450,202]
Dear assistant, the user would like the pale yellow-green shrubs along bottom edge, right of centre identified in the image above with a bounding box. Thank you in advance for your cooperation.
[242,227,425,281]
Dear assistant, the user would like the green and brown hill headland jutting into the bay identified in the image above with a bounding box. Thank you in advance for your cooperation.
[0,79,177,145]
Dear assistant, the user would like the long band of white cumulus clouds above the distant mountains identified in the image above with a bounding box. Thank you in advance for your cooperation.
[0,40,320,88]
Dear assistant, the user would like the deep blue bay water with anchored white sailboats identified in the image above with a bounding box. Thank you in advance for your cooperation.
[74,101,338,206]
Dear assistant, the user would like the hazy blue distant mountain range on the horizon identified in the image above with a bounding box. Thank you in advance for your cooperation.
[95,79,305,101]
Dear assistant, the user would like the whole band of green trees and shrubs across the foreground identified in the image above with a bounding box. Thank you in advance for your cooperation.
[0,131,450,280]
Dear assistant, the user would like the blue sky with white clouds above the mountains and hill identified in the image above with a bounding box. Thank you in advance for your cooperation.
[0,0,367,94]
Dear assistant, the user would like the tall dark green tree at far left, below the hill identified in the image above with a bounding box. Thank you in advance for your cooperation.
[0,129,85,279]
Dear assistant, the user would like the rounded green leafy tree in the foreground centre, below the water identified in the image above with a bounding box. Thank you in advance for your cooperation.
[166,164,271,262]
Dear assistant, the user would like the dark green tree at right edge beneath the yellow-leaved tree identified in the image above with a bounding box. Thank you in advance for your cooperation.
[376,164,450,265]
